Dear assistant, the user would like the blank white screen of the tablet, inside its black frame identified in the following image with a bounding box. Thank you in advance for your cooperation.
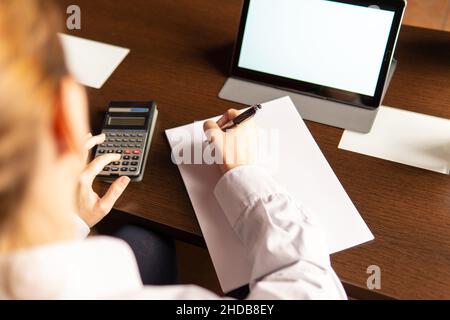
[238,0,394,97]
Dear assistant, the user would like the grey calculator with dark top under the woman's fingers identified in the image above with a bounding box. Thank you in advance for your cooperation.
[95,101,158,182]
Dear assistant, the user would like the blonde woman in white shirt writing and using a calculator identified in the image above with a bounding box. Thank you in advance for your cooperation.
[0,0,346,299]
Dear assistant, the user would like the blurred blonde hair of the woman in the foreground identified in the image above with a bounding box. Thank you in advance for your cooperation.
[0,0,67,224]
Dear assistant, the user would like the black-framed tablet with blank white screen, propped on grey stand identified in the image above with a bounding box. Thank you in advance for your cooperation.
[231,0,406,109]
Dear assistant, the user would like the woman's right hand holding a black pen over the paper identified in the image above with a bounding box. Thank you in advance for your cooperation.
[203,109,258,173]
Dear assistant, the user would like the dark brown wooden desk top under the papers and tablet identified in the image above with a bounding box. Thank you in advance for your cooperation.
[61,0,450,298]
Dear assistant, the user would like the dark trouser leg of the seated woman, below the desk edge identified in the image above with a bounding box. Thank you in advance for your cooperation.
[112,225,177,285]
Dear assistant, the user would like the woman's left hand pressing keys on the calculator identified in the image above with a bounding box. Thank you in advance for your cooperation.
[78,134,130,228]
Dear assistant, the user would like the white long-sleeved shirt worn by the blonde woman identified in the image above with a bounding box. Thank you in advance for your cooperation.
[0,166,347,299]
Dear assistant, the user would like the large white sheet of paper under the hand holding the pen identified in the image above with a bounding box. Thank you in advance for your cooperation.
[166,97,373,292]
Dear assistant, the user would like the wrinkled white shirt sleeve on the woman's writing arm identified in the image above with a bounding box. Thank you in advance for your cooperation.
[214,166,347,299]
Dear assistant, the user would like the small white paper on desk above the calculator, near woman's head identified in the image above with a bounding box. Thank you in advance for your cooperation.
[59,34,130,89]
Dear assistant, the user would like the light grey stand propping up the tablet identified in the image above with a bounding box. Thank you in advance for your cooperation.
[219,59,397,133]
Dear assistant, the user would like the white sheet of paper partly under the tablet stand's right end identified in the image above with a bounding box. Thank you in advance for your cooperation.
[339,106,450,174]
